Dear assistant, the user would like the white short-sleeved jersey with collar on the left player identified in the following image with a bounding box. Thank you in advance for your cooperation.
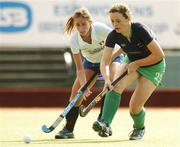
[70,22,112,63]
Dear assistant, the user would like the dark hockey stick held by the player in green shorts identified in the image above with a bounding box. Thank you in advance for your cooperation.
[79,71,127,117]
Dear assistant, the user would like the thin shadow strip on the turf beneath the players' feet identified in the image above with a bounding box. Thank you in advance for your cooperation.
[0,138,129,144]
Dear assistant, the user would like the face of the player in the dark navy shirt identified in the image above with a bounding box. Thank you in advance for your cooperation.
[110,12,129,33]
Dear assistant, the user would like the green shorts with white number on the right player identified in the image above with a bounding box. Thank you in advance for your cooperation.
[123,56,166,86]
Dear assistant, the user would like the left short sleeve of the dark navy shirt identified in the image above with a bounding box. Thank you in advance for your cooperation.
[105,31,116,48]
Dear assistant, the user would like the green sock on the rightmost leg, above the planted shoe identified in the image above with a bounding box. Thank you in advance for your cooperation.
[130,108,146,129]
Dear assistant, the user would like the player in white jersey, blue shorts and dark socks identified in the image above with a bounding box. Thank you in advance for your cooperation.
[55,8,123,139]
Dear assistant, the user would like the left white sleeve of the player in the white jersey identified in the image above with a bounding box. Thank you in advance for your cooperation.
[70,34,80,54]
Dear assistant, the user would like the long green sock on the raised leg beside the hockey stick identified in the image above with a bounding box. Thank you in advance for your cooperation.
[101,91,121,125]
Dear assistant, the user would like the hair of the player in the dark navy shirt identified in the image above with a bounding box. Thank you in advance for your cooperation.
[109,3,132,20]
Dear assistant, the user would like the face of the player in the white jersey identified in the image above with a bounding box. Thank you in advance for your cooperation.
[74,17,91,37]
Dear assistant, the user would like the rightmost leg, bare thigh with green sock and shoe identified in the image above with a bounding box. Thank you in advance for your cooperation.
[129,76,156,140]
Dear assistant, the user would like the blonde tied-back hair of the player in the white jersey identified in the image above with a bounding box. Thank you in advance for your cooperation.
[65,8,93,34]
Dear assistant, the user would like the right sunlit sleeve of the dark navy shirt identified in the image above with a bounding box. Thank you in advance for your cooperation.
[138,24,155,45]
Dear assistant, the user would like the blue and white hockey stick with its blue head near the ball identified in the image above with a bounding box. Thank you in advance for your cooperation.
[42,72,97,133]
